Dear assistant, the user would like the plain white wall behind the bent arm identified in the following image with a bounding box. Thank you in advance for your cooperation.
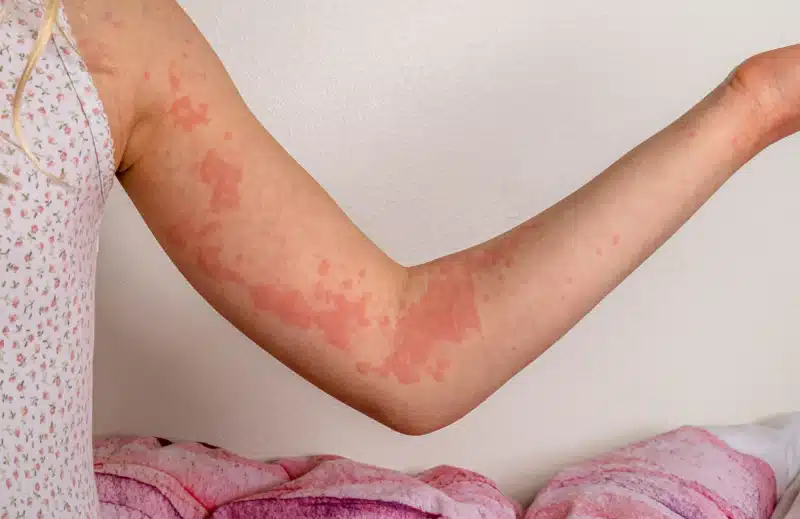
[90,0,800,501]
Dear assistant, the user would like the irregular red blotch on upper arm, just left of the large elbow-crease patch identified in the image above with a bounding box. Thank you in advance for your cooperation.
[249,284,369,350]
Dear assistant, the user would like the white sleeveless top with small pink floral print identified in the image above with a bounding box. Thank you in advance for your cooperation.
[0,0,115,519]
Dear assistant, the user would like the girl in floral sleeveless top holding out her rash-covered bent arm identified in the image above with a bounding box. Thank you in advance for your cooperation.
[0,0,800,519]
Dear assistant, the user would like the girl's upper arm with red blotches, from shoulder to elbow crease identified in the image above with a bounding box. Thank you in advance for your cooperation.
[112,0,407,420]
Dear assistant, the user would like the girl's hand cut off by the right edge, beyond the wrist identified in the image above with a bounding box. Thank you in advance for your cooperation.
[727,45,800,146]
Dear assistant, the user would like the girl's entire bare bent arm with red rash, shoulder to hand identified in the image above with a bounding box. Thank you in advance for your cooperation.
[61,0,800,434]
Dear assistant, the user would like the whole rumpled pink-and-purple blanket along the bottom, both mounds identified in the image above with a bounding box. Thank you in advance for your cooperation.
[95,428,782,519]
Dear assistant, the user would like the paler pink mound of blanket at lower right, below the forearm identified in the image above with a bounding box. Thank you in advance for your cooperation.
[526,428,777,519]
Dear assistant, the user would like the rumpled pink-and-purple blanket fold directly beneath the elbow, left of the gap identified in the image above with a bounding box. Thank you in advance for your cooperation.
[95,438,520,519]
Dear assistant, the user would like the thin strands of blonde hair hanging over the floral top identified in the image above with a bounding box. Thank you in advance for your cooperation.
[0,0,69,184]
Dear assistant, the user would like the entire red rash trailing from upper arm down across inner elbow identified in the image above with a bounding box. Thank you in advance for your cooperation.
[141,25,540,385]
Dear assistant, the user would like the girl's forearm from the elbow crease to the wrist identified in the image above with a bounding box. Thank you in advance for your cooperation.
[394,80,763,430]
